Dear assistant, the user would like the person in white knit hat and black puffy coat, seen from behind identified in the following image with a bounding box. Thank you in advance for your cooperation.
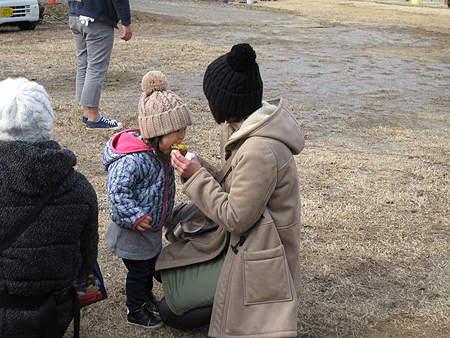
[0,78,98,338]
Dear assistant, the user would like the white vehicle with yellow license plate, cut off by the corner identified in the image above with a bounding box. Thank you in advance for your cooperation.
[0,0,40,30]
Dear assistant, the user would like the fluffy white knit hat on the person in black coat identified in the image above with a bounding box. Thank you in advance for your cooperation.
[0,78,55,142]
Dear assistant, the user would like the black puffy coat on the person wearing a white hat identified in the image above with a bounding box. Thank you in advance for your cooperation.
[0,141,98,338]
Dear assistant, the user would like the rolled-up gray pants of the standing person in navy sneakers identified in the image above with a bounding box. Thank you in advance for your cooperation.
[69,16,114,107]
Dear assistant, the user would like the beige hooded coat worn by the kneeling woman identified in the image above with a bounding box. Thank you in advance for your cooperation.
[156,99,304,338]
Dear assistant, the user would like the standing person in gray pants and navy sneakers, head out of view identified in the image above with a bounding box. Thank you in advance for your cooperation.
[68,0,133,130]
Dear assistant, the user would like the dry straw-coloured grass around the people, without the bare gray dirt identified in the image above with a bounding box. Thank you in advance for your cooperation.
[0,0,450,338]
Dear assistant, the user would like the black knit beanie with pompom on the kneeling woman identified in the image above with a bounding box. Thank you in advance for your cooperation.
[203,43,263,116]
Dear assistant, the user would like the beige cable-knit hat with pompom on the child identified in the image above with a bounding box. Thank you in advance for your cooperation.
[138,71,192,139]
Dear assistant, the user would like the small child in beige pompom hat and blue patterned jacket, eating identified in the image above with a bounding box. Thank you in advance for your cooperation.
[102,71,192,328]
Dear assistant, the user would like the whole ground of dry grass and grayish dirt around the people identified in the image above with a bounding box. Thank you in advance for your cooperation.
[0,0,450,338]
